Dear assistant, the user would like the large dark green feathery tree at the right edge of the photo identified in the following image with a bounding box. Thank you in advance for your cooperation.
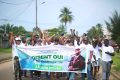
[105,11,120,44]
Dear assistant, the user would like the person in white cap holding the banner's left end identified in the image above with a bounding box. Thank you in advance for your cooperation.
[9,32,23,80]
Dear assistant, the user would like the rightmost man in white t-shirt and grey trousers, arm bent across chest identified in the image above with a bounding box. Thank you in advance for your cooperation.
[102,39,114,80]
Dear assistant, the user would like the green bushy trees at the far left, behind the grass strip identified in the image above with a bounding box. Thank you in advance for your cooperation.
[0,23,26,48]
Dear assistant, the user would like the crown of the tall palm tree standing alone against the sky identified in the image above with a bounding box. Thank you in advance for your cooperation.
[59,7,73,31]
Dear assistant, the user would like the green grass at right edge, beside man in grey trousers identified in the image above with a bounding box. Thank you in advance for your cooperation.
[113,53,120,71]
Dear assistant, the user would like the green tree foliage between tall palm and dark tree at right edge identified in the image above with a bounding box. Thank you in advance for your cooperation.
[87,24,103,39]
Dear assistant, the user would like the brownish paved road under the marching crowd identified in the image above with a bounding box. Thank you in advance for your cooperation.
[0,61,117,80]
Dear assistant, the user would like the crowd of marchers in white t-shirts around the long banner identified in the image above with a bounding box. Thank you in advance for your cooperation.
[9,32,114,80]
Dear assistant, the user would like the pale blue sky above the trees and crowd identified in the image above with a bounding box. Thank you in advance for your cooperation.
[0,0,120,35]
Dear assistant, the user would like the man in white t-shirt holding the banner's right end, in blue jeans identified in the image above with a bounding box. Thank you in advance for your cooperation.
[80,37,96,80]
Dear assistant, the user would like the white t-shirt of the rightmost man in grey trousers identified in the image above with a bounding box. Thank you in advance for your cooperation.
[102,45,114,61]
